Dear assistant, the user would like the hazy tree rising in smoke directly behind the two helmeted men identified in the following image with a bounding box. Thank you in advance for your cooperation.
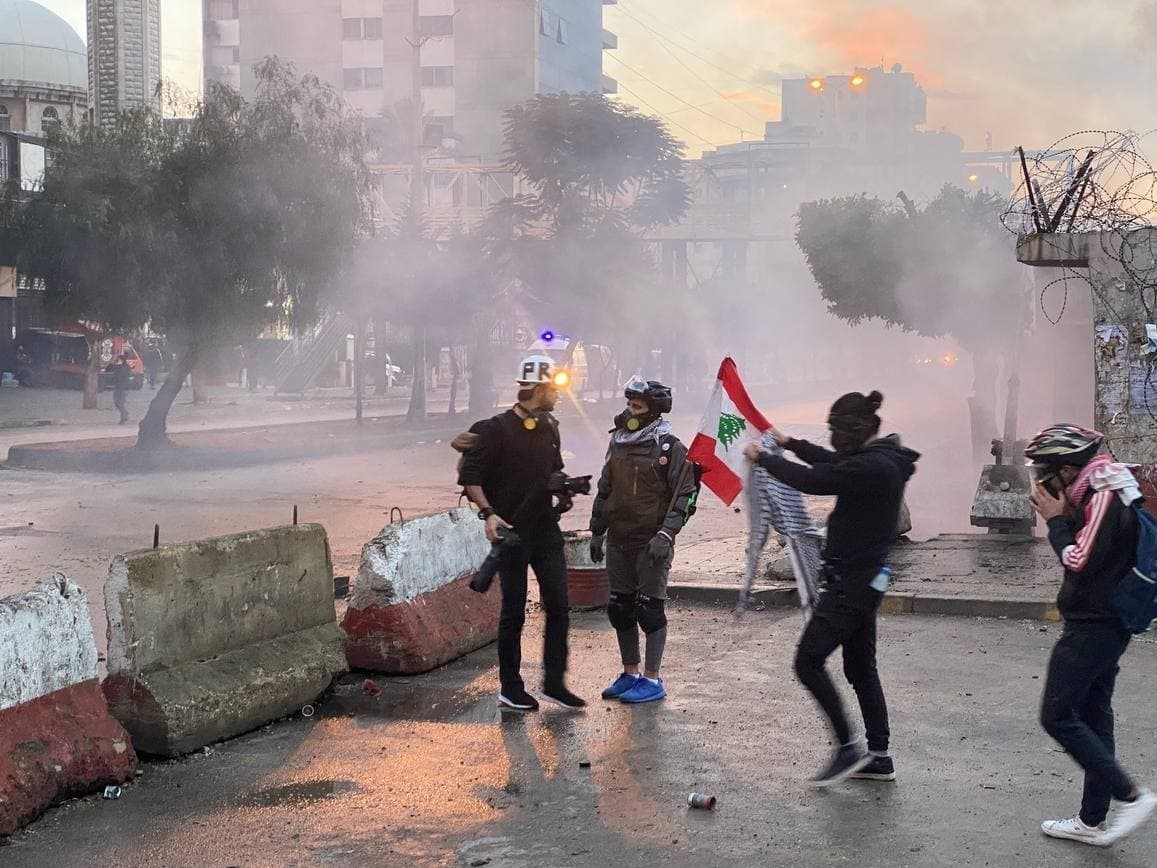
[485,94,690,374]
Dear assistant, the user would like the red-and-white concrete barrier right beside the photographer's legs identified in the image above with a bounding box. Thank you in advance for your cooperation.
[342,507,492,675]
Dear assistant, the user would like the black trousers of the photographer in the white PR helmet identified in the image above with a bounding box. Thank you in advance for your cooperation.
[499,536,570,692]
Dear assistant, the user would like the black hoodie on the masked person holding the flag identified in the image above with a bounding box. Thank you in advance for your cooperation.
[759,434,920,582]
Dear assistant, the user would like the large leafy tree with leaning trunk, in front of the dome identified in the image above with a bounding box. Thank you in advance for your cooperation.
[0,59,364,450]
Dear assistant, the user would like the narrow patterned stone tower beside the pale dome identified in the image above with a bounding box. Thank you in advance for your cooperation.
[88,0,161,126]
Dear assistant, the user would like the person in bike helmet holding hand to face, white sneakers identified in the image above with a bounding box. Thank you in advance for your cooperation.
[1024,425,1157,847]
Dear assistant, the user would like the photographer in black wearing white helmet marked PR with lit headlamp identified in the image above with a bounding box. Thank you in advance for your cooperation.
[458,355,585,711]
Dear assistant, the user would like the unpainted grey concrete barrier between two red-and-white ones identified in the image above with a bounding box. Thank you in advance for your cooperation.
[104,524,345,756]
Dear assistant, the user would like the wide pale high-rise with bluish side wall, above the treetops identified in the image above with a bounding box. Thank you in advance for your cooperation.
[202,0,617,161]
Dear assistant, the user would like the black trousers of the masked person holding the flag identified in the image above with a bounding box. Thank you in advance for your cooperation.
[795,582,891,753]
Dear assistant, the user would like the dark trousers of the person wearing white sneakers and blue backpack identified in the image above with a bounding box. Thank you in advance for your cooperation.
[1040,621,1134,826]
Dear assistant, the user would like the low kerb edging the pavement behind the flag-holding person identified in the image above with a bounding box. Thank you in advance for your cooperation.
[668,583,1061,623]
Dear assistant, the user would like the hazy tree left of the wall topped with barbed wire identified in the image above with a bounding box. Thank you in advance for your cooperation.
[796,185,1030,455]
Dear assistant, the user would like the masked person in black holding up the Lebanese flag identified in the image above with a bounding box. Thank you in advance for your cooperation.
[745,391,920,786]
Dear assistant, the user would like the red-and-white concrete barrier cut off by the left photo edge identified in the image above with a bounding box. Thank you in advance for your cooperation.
[0,576,137,834]
